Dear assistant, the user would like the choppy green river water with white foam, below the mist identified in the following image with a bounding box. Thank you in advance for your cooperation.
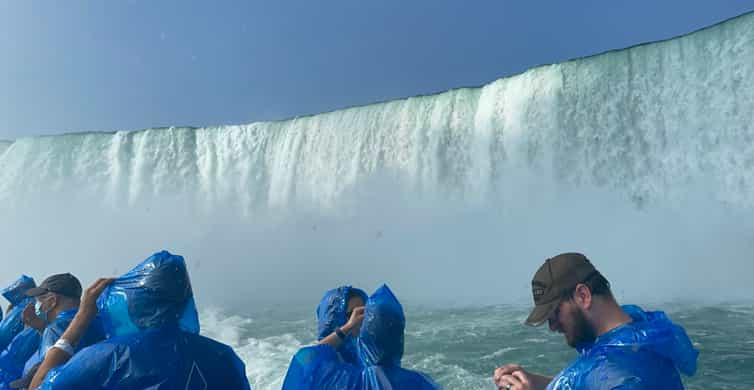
[201,304,754,390]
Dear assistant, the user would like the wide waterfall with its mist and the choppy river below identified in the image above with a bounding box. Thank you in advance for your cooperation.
[0,9,754,388]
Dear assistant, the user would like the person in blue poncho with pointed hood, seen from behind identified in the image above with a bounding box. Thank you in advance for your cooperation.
[283,285,440,390]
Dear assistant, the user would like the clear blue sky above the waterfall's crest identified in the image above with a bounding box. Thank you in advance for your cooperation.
[0,0,754,139]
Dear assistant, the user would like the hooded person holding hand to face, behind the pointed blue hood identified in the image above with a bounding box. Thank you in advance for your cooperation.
[317,286,367,363]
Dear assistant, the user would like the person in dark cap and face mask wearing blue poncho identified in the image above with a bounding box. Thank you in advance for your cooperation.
[10,273,104,389]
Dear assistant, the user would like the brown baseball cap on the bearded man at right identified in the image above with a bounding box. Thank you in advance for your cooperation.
[526,253,599,326]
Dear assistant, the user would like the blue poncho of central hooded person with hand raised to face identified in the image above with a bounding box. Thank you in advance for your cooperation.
[317,286,368,363]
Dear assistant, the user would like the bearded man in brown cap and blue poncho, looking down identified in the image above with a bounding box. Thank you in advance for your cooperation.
[493,253,699,390]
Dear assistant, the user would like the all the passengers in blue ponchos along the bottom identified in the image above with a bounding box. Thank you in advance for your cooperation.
[0,251,698,390]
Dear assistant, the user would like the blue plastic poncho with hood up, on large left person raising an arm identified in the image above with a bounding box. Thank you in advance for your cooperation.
[40,251,250,390]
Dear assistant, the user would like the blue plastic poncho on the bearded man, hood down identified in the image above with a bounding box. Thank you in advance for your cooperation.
[547,306,699,390]
